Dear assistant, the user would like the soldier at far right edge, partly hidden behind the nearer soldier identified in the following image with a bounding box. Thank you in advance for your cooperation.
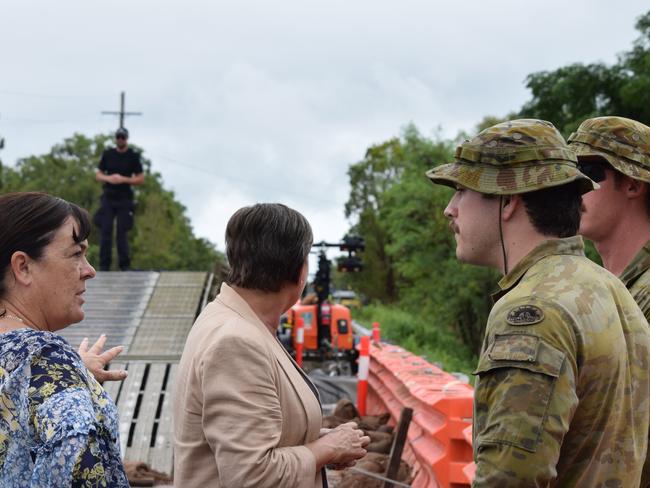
[569,117,650,486]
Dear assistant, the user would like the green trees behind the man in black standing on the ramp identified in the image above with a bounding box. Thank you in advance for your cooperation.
[0,134,224,271]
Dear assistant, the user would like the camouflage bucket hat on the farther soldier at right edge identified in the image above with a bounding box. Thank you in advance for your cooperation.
[569,117,650,183]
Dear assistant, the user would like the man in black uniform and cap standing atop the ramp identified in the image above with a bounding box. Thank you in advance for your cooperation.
[95,127,144,271]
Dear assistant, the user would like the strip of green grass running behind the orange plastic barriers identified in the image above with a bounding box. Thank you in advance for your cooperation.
[355,305,476,376]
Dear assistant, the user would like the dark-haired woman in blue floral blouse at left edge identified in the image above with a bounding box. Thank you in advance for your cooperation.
[0,193,129,488]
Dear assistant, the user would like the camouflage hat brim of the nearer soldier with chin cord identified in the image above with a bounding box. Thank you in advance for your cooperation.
[426,160,599,195]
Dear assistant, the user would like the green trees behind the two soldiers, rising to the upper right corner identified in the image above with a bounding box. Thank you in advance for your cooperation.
[339,12,650,352]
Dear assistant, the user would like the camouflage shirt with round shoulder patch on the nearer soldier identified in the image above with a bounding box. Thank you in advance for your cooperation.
[473,237,650,488]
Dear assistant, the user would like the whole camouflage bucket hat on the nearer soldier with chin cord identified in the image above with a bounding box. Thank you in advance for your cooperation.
[426,119,598,195]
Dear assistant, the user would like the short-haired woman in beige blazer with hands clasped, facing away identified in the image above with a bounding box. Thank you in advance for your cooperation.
[173,204,370,488]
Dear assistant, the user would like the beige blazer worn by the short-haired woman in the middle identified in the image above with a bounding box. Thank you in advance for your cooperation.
[173,284,323,488]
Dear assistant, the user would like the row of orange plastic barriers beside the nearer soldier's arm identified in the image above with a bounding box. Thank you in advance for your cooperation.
[367,344,474,488]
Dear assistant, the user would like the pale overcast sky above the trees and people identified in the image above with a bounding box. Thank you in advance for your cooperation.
[0,0,650,255]
